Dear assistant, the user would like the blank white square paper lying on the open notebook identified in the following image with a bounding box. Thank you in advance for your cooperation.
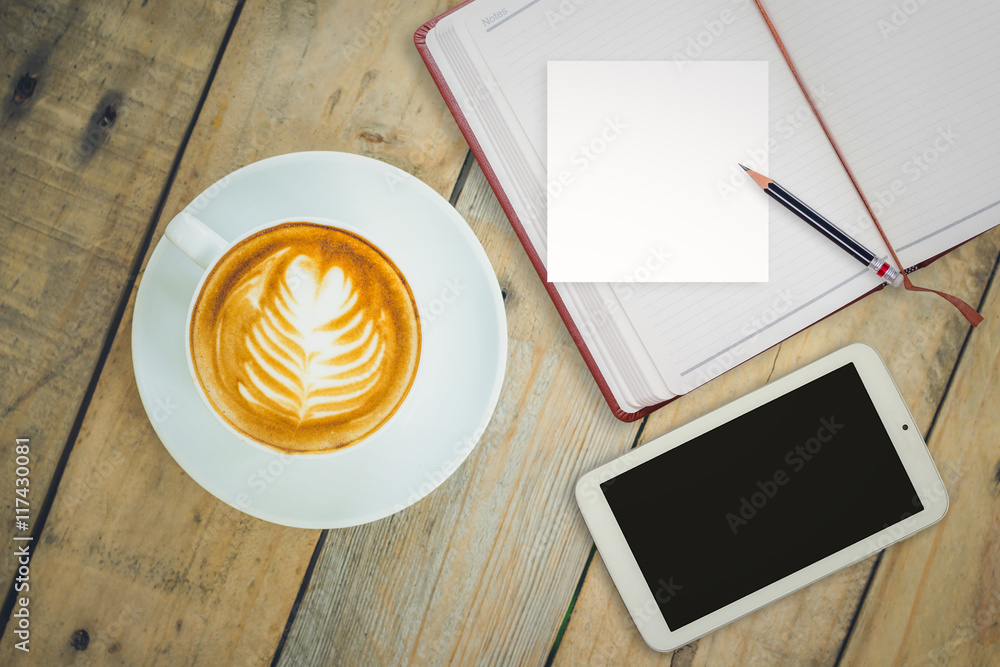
[547,61,770,283]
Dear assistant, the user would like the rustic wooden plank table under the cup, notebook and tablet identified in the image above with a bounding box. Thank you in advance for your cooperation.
[0,0,1000,665]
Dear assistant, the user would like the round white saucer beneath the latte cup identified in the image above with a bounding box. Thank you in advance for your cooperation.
[132,152,507,528]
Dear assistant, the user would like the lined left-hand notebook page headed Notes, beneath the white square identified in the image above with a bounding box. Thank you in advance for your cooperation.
[455,0,896,394]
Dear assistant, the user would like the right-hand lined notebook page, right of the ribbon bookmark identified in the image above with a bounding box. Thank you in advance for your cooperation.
[764,0,1000,266]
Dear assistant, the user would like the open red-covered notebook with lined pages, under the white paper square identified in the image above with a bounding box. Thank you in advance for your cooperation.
[415,0,1000,419]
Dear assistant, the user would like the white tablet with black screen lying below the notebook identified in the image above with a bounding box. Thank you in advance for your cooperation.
[576,344,948,651]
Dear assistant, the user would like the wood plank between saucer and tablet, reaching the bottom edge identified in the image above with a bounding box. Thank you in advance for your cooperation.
[279,166,638,665]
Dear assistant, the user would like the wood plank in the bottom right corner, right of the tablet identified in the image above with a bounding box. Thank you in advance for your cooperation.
[844,258,1000,665]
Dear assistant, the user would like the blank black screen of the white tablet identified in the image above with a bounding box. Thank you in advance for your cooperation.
[601,363,923,630]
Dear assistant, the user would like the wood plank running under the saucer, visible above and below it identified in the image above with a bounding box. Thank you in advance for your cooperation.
[0,0,467,665]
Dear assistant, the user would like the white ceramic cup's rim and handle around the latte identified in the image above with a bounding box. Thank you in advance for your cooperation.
[163,209,419,457]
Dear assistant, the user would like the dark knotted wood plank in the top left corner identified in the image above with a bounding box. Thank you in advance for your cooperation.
[0,0,234,593]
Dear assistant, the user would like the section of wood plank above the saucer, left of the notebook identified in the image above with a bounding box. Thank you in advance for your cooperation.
[172,0,467,196]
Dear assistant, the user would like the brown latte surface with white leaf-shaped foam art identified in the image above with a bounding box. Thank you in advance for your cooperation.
[190,222,420,453]
